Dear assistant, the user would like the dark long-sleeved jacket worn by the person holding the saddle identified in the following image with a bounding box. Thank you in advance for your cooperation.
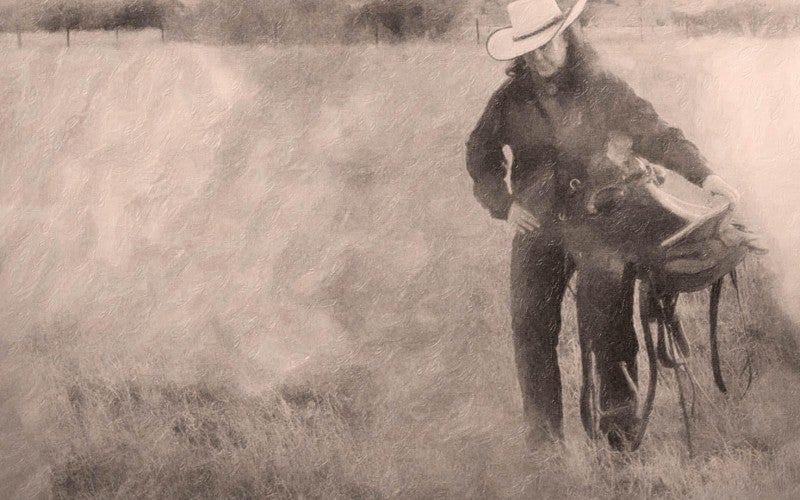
[467,67,711,219]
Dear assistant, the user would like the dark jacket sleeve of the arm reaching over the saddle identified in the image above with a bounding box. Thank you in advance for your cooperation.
[612,79,712,185]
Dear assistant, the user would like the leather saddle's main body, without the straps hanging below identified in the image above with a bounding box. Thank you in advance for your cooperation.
[556,156,765,296]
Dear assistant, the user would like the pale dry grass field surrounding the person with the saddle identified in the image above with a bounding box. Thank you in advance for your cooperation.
[0,30,800,498]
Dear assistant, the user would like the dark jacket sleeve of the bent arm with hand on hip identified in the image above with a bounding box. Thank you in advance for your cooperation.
[467,88,512,219]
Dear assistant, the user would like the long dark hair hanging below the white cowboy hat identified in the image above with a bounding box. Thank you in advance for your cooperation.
[506,22,600,89]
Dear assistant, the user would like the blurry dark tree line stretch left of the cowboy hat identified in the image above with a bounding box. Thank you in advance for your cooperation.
[0,0,467,43]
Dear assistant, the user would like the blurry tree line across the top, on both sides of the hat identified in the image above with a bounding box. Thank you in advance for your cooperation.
[0,0,800,43]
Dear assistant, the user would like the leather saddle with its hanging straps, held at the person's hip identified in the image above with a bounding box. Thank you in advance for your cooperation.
[521,136,766,449]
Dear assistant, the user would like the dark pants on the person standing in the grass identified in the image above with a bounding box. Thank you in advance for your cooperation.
[511,232,638,447]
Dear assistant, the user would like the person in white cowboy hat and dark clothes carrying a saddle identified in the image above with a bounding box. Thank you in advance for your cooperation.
[466,0,739,449]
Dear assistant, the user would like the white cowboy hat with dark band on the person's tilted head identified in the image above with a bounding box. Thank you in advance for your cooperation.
[486,0,586,61]
